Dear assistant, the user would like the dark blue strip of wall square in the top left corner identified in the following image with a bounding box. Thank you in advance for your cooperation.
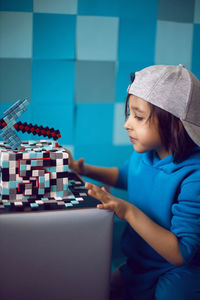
[0,0,33,11]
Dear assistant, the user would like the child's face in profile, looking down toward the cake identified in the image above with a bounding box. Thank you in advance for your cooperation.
[124,95,169,159]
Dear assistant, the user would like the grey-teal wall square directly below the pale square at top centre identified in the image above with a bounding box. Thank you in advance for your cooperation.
[75,61,115,103]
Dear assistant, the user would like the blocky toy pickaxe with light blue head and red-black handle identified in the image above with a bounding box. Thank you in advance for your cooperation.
[0,99,61,150]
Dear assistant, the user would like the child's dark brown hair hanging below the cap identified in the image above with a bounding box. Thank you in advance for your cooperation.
[125,95,196,163]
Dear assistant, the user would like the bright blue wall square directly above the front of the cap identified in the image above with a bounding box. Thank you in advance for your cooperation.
[118,18,157,64]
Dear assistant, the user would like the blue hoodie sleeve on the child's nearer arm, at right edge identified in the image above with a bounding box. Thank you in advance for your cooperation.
[171,174,200,264]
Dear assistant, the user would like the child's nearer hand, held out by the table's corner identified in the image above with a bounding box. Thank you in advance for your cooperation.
[85,182,131,219]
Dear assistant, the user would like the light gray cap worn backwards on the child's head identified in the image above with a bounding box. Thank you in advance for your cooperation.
[128,65,200,146]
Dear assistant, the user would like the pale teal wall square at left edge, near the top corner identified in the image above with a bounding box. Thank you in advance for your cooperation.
[0,12,32,58]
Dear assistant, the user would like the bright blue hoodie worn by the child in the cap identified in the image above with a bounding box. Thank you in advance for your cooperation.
[117,147,200,273]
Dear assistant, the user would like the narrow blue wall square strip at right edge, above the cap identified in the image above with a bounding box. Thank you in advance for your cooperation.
[192,24,200,80]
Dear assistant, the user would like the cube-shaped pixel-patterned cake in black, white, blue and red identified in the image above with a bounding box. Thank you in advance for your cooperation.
[0,140,69,201]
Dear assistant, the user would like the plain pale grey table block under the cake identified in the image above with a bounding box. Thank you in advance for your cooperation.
[0,208,113,300]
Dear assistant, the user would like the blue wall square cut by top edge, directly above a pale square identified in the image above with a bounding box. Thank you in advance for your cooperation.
[78,0,120,17]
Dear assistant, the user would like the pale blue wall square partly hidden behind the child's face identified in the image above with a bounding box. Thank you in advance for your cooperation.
[113,103,130,145]
